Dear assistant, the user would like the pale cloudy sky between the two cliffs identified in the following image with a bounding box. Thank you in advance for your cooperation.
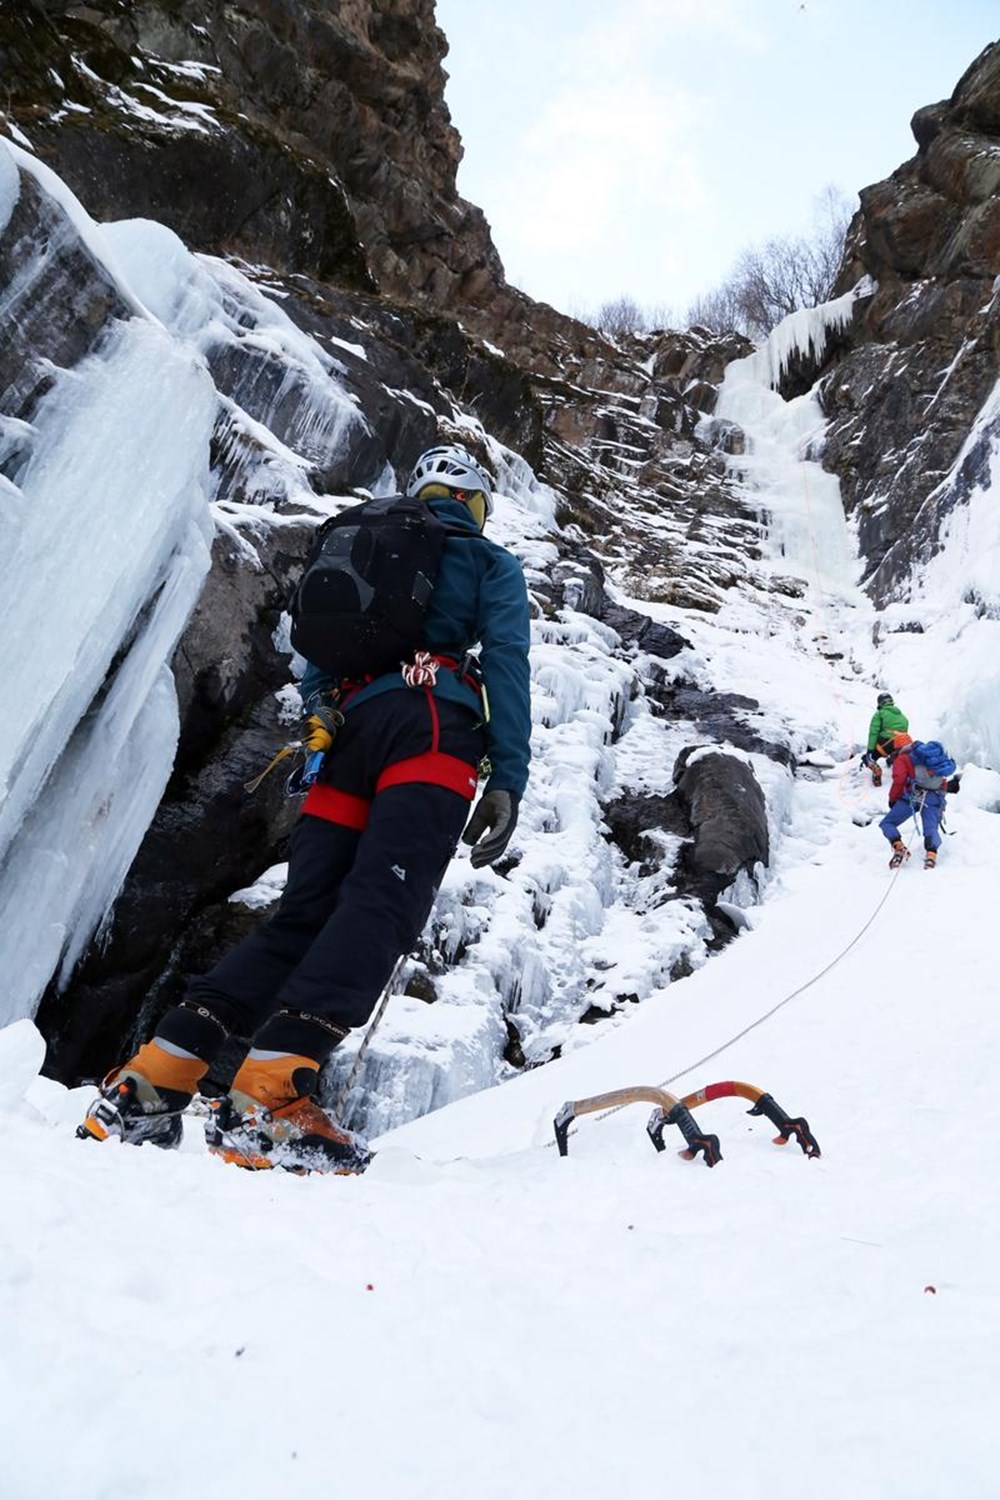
[436,0,1000,315]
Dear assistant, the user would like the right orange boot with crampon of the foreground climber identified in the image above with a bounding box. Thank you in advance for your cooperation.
[205,1053,372,1173]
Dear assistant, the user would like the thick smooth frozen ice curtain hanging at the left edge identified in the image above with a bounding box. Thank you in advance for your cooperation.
[0,318,216,1019]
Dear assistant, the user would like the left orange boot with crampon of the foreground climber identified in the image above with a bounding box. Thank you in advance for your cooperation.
[76,1041,208,1151]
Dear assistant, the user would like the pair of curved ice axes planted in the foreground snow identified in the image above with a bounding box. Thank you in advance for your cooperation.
[552,1079,820,1167]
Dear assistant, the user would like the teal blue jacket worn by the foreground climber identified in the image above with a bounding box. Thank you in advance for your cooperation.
[300,498,531,797]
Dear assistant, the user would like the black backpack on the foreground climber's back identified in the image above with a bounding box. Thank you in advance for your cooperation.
[289,495,455,681]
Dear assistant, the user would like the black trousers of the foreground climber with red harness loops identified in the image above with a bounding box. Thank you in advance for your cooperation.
[167,689,484,1061]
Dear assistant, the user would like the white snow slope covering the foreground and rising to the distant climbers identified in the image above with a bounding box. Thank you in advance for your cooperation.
[0,279,1000,1500]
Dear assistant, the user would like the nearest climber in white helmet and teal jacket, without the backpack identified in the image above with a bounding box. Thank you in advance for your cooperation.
[78,447,531,1170]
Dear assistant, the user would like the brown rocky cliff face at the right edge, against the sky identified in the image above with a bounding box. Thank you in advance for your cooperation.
[813,44,1000,603]
